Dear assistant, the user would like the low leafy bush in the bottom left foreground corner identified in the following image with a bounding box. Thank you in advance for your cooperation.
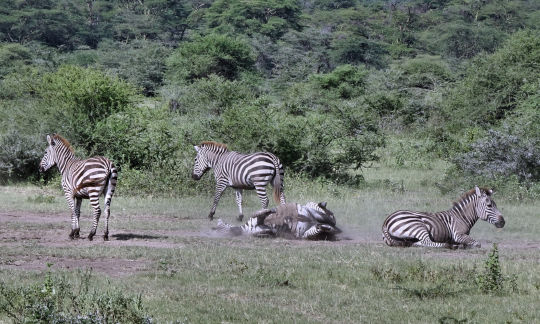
[0,271,152,324]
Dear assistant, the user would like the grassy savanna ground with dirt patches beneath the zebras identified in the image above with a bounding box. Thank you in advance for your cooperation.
[0,162,540,323]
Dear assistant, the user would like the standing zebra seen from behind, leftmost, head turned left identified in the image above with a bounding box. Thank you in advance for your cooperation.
[39,134,118,241]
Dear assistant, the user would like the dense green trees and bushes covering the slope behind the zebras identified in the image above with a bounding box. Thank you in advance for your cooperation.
[0,0,540,194]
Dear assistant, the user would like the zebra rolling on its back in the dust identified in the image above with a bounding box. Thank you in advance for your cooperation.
[215,202,341,240]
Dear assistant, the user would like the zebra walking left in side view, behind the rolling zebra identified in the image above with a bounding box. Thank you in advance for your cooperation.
[193,142,285,220]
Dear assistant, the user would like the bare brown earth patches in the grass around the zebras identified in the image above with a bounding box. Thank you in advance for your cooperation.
[0,212,540,277]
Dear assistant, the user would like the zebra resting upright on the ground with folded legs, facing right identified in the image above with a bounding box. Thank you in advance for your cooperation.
[382,186,505,248]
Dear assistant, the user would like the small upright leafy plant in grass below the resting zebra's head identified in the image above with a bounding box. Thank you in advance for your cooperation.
[475,243,517,293]
